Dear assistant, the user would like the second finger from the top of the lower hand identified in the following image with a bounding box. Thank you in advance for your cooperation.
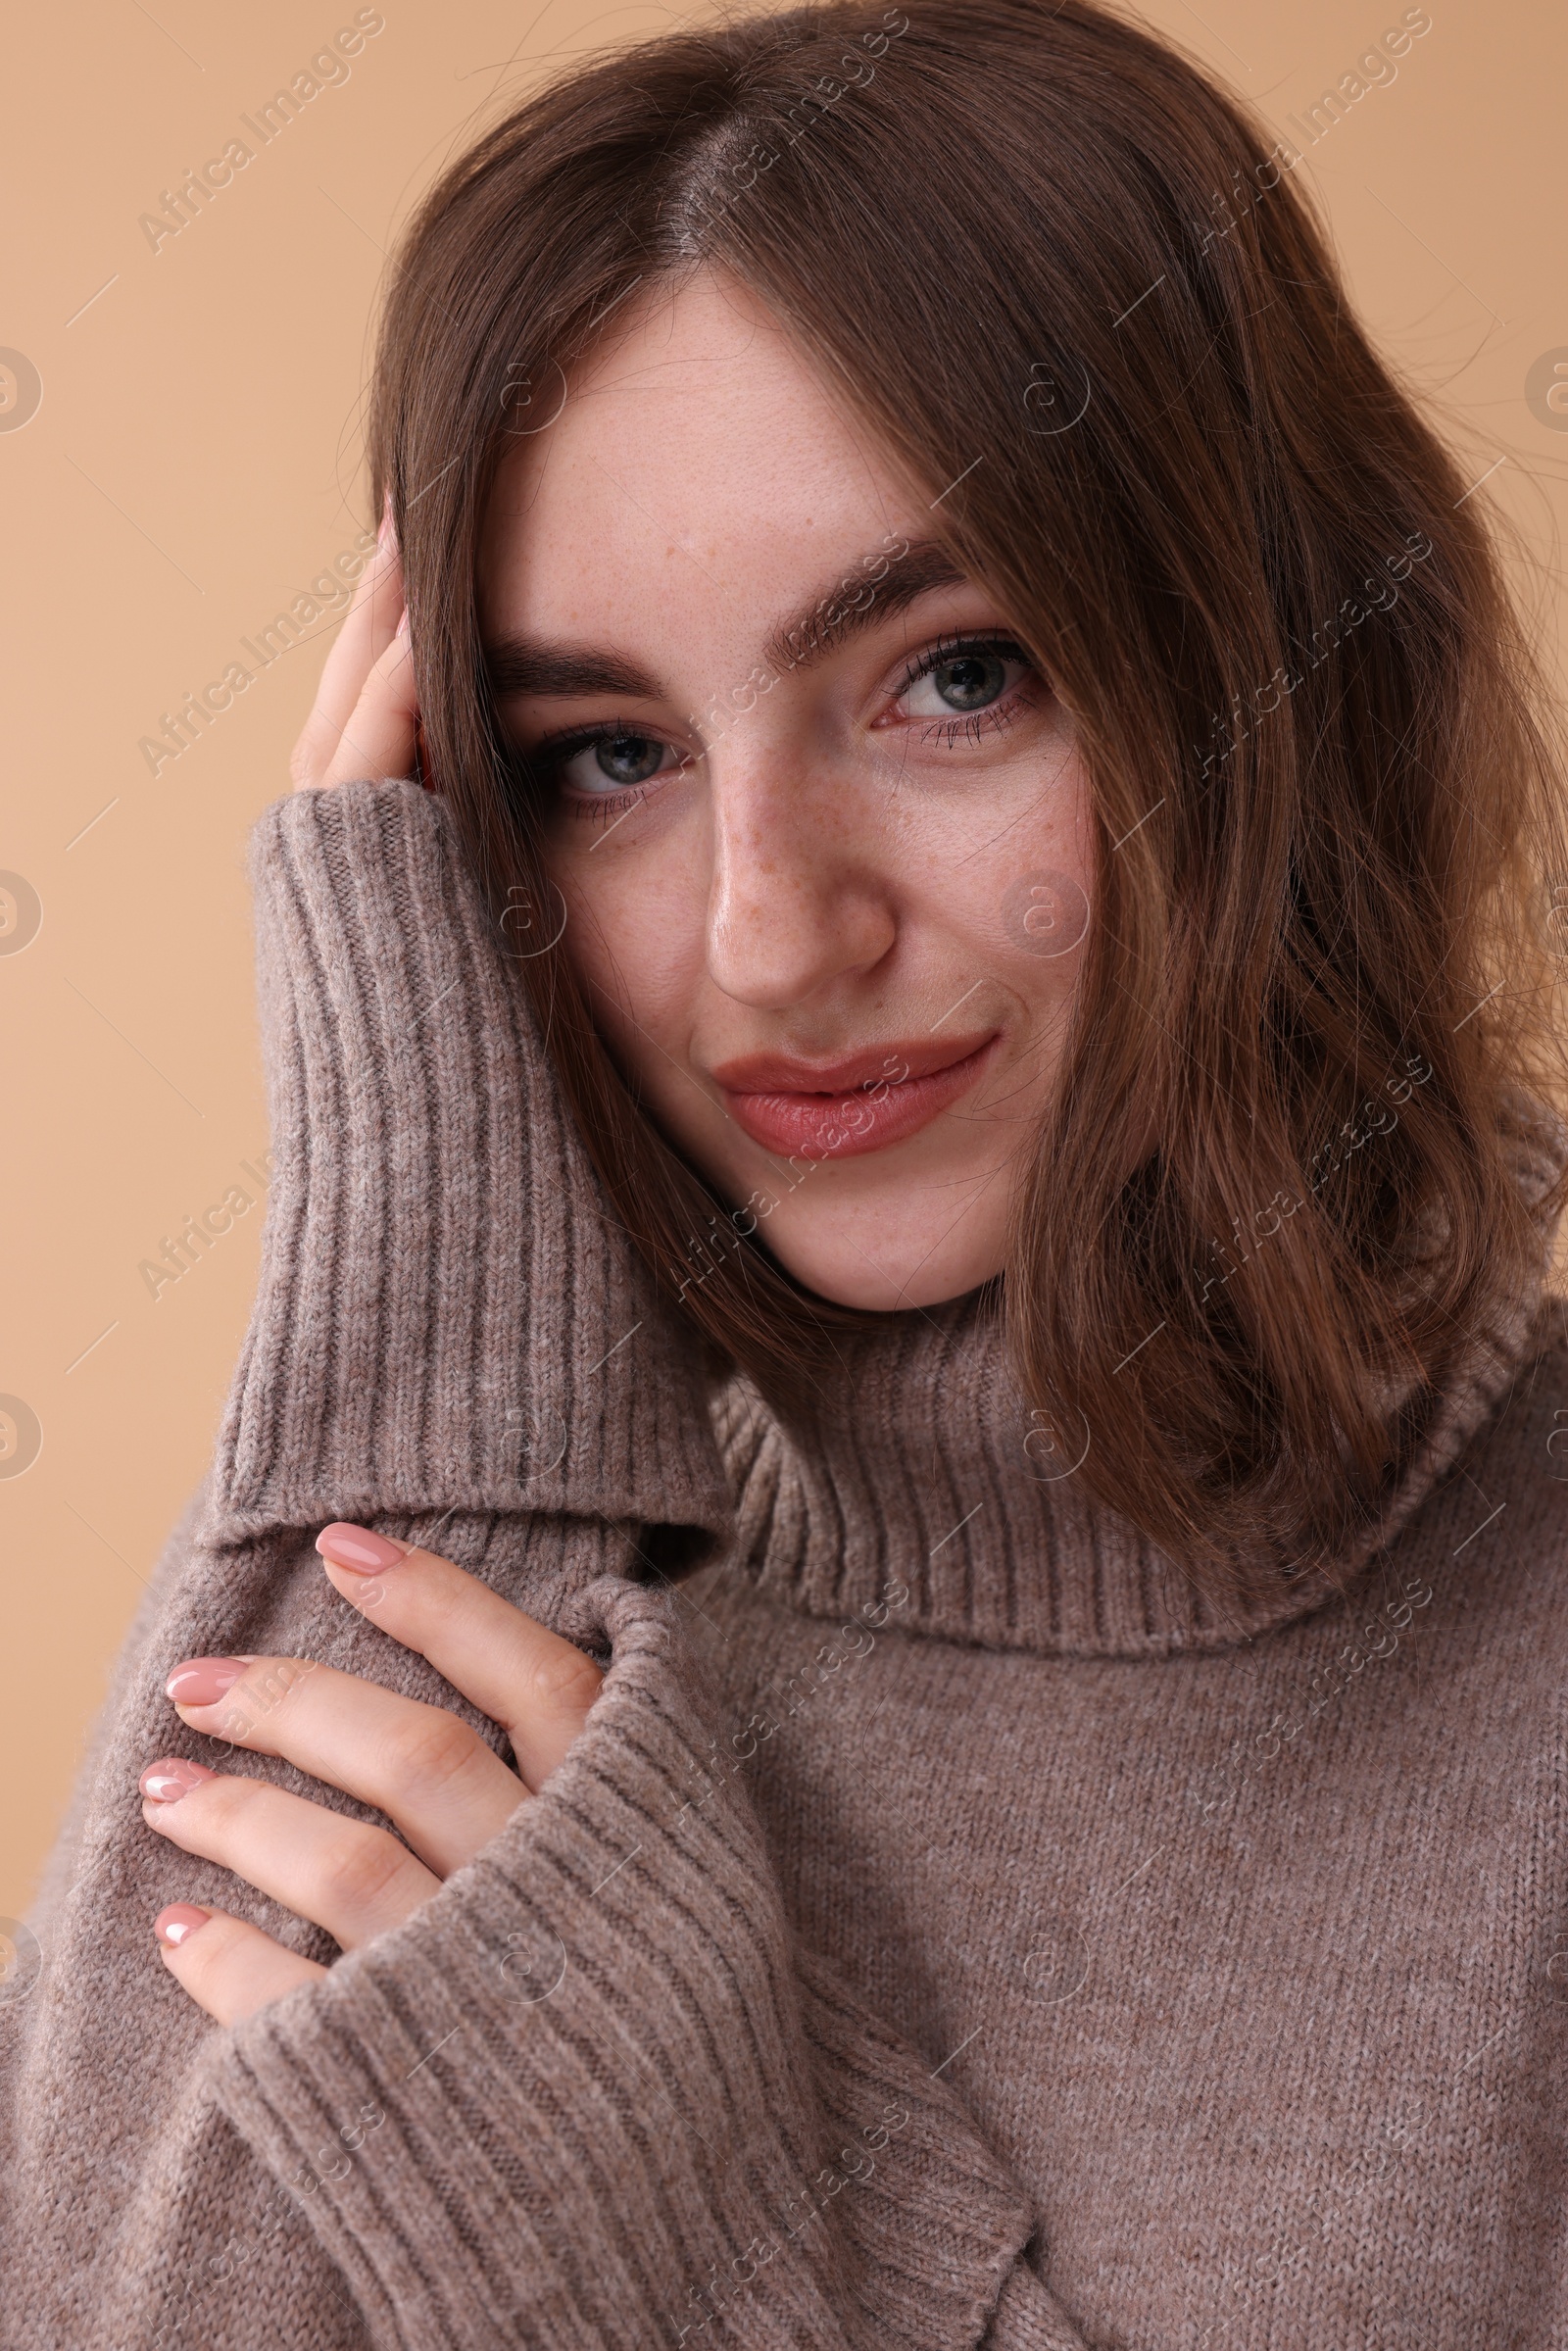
[167,1657,529,1879]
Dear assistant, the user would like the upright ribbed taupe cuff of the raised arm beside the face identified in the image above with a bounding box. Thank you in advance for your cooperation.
[212,783,729,1538]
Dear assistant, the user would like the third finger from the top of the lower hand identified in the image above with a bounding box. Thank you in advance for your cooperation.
[141,1758,442,1951]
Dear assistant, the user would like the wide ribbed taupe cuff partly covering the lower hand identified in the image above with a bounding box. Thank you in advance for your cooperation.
[207,1578,1032,2351]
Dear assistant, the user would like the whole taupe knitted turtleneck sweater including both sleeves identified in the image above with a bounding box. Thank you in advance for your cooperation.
[12,783,1568,2351]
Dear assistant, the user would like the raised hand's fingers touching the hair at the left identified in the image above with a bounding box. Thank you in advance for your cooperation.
[289,501,418,792]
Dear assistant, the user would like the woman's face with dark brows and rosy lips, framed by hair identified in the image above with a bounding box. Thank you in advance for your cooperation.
[479,272,1093,1309]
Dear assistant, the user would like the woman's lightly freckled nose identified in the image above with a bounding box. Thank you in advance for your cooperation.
[708,745,898,1011]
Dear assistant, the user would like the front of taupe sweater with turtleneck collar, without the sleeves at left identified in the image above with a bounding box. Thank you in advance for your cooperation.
[684,1147,1568,2351]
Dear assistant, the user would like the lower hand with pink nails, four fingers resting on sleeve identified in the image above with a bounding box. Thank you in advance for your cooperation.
[141,1526,602,2025]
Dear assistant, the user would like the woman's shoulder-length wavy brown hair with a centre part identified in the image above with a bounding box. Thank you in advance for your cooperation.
[371,0,1568,1587]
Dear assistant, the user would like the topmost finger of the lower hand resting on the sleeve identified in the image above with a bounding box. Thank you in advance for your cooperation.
[315,1524,604,1789]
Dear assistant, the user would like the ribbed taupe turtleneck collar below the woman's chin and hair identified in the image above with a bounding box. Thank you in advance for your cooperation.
[714,1105,1568,1657]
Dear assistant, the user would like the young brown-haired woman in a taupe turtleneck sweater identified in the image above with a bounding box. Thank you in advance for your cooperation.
[0,0,1568,2351]
